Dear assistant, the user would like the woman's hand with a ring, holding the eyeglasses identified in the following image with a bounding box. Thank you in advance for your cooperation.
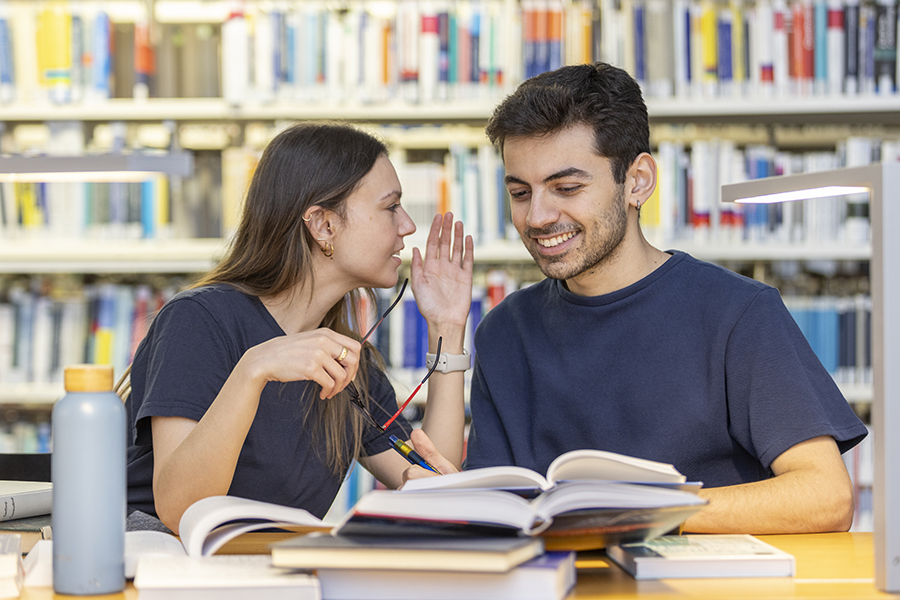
[244,327,361,399]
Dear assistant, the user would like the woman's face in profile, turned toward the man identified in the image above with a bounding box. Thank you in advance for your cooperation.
[332,155,416,288]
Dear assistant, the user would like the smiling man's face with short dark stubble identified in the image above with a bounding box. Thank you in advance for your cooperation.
[503,125,628,280]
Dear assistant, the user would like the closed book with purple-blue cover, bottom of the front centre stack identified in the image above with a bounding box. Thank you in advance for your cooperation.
[316,552,575,600]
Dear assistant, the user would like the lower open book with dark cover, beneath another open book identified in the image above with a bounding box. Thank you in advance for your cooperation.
[335,481,706,548]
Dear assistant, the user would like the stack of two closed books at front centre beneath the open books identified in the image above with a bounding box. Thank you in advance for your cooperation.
[272,533,575,600]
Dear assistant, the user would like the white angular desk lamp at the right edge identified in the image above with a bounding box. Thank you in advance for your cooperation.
[722,162,900,592]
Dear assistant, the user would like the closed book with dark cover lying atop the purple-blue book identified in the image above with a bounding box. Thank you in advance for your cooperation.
[272,532,544,573]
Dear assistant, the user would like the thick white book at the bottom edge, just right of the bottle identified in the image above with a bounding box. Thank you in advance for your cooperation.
[134,554,322,600]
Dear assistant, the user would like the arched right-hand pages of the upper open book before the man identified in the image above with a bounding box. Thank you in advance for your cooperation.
[547,450,686,483]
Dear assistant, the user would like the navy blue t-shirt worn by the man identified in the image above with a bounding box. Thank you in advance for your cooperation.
[466,252,866,487]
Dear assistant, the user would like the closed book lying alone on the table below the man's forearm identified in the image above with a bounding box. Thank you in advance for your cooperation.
[606,535,795,579]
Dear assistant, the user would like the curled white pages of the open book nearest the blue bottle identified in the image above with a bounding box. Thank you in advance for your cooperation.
[178,496,326,556]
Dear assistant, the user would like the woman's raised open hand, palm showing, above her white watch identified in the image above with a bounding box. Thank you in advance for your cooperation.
[411,212,474,328]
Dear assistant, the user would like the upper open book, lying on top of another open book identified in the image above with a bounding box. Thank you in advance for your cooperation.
[403,450,700,491]
